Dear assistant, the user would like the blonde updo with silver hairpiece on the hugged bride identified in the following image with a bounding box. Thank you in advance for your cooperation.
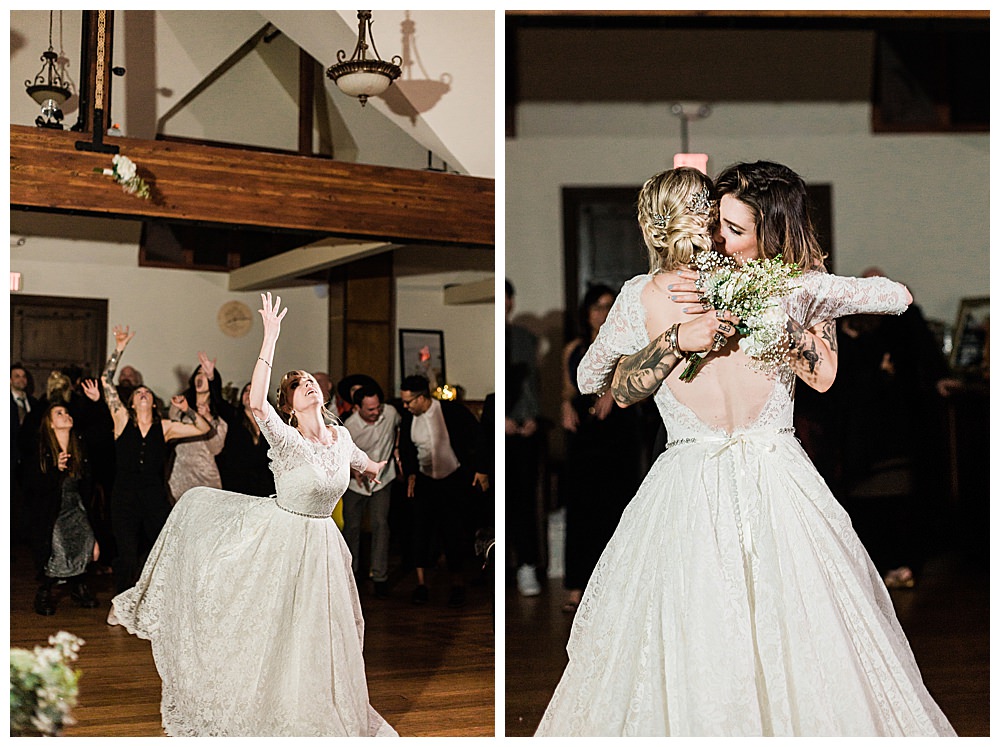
[638,166,718,272]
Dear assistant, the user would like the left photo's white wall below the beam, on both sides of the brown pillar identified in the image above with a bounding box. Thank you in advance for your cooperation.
[10,236,495,406]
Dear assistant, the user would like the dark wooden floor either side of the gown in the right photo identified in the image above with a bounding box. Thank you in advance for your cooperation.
[505,553,990,737]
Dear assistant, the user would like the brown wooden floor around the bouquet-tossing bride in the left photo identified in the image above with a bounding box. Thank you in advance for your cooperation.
[10,552,496,737]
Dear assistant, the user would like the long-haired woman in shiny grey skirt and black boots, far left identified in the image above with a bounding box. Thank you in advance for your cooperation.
[26,401,99,615]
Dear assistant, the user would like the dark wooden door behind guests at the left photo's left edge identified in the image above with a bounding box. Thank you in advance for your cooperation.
[10,295,108,397]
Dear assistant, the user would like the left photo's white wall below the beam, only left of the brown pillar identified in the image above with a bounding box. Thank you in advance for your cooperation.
[10,236,327,400]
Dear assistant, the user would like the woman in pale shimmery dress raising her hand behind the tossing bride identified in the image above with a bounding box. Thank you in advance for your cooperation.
[167,352,233,503]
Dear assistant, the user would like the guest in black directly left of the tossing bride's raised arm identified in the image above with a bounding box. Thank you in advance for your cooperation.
[216,384,274,496]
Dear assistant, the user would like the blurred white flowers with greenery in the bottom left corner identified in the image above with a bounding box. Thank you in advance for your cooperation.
[10,630,83,737]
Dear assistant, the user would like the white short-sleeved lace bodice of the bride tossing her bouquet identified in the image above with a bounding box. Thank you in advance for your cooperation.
[257,404,368,517]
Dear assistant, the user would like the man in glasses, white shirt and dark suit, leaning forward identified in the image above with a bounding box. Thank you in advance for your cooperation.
[399,376,478,607]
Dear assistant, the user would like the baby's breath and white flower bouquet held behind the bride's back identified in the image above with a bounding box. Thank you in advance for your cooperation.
[681,251,802,381]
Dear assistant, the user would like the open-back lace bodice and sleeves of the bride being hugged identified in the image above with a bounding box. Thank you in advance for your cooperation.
[577,272,907,441]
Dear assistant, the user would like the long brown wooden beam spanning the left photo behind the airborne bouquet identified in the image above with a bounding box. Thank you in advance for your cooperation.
[10,125,494,248]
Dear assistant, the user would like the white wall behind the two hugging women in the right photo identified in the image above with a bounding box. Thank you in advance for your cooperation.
[505,104,989,323]
